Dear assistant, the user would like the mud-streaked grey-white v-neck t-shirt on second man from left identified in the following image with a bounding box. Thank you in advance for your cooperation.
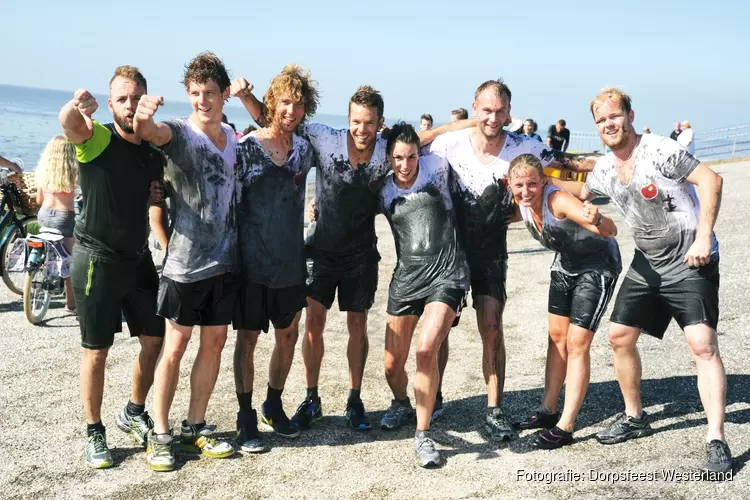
[163,118,237,283]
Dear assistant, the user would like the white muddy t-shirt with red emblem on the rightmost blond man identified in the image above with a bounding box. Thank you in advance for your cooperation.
[586,134,719,286]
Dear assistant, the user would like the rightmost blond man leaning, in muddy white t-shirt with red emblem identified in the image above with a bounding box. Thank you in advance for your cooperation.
[563,89,733,478]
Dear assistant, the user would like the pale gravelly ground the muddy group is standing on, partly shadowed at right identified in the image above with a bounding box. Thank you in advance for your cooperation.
[0,163,750,499]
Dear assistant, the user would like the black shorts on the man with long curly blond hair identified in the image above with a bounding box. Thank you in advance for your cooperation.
[232,281,307,332]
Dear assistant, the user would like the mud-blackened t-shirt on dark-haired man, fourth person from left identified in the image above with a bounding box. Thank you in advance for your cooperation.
[300,123,389,255]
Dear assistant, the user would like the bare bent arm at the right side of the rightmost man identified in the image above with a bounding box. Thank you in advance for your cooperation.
[684,164,724,267]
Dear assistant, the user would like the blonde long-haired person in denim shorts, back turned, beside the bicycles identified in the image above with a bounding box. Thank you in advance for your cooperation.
[36,135,78,311]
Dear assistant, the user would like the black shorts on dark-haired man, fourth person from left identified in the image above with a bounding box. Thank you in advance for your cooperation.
[307,247,380,312]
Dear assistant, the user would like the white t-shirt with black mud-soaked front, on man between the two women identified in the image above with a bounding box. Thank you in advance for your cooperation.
[424,129,562,266]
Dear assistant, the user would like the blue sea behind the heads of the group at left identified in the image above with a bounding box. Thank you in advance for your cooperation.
[0,85,356,171]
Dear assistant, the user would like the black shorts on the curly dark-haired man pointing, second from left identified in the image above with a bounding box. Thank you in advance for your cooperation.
[158,273,240,326]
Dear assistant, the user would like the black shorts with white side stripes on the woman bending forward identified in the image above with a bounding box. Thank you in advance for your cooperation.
[547,271,617,332]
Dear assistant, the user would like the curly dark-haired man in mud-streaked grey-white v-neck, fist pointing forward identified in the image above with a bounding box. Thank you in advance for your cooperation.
[134,52,239,471]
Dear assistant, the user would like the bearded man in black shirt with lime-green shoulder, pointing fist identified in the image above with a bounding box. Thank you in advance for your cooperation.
[59,66,169,468]
